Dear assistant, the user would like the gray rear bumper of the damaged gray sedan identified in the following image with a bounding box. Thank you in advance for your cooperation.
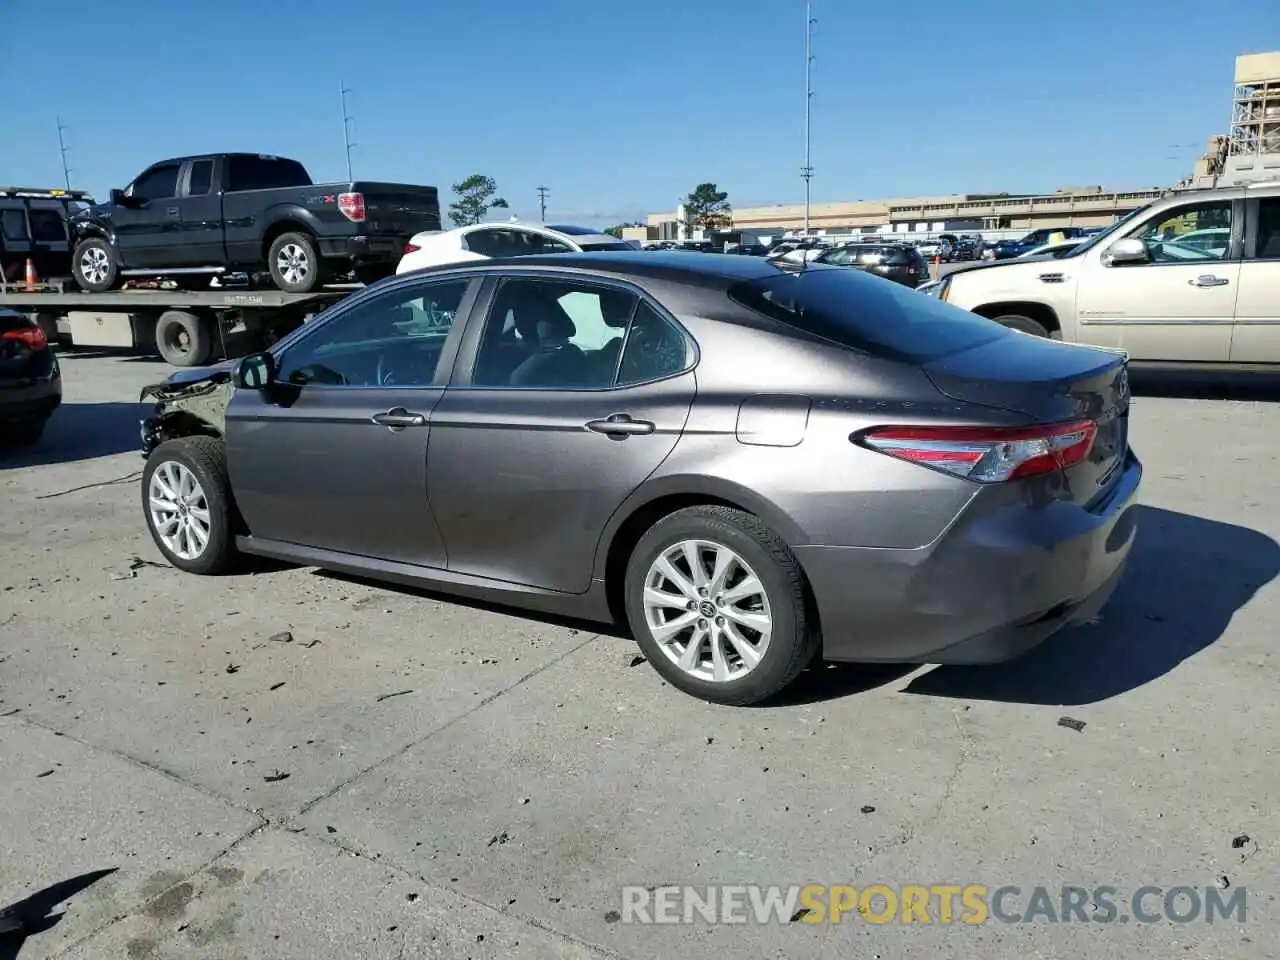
[795,452,1142,663]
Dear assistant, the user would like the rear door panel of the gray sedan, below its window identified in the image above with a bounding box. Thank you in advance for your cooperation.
[428,372,694,593]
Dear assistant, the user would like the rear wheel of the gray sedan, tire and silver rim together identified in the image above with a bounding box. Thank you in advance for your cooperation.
[626,506,820,705]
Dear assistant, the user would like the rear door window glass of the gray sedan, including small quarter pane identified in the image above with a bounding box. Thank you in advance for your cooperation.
[471,279,687,389]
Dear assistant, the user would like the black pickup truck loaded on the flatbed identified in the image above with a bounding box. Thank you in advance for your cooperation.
[70,154,440,293]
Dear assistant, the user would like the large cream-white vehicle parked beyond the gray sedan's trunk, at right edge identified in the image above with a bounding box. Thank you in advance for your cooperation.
[922,182,1280,365]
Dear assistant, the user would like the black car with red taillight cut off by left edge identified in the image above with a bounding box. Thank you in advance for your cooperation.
[0,307,63,445]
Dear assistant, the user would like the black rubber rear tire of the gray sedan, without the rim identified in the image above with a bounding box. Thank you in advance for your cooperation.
[626,506,822,707]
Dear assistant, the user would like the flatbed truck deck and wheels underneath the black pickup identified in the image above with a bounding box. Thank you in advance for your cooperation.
[0,278,362,366]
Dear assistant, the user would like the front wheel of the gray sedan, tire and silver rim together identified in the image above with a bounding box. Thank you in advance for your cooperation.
[142,436,238,573]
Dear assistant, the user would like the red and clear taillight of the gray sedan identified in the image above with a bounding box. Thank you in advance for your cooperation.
[856,420,1098,484]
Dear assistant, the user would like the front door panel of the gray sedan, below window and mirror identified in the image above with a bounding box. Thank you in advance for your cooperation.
[227,384,444,567]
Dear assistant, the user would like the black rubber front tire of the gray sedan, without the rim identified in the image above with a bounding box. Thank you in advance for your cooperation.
[142,436,241,576]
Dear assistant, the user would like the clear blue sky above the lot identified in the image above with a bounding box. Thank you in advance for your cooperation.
[0,0,1280,224]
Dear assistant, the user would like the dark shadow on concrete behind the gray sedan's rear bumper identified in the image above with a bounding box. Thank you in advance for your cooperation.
[904,507,1280,705]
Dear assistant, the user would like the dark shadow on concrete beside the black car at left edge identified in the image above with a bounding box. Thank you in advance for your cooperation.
[0,403,151,470]
